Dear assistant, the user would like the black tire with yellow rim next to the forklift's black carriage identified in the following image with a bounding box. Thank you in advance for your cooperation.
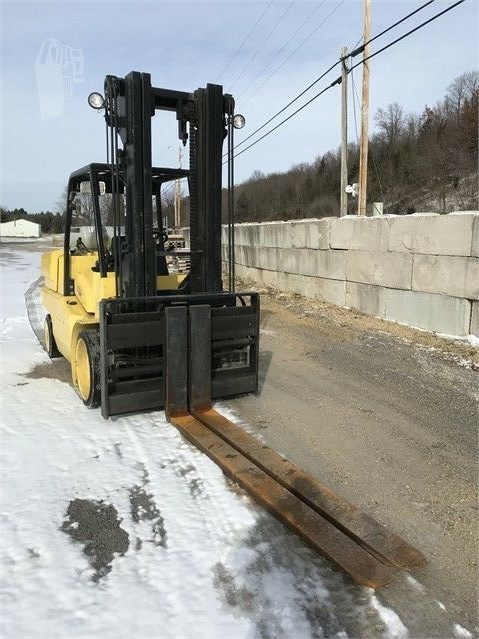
[74,330,101,408]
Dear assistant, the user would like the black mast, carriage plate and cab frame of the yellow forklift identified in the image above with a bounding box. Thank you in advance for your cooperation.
[78,72,259,418]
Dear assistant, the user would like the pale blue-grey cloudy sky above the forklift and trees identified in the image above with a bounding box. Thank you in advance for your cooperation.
[0,0,478,212]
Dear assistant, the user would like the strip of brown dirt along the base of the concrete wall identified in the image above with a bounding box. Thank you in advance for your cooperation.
[242,281,479,370]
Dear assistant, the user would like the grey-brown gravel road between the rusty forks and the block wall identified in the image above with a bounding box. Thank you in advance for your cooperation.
[229,296,479,637]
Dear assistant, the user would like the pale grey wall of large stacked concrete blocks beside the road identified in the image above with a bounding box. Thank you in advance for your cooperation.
[218,211,479,336]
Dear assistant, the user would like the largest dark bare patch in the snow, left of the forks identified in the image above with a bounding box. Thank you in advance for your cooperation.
[60,499,130,582]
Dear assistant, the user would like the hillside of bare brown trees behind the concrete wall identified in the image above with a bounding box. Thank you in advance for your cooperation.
[225,71,479,222]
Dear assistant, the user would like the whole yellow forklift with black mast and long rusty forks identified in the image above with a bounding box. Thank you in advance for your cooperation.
[42,72,425,587]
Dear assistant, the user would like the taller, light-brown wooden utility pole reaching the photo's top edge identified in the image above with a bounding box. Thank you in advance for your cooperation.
[358,0,371,215]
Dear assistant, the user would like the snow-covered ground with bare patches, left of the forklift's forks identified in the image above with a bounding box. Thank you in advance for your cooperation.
[0,247,464,639]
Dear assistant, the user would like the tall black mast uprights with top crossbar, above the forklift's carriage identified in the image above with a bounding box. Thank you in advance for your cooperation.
[105,71,234,297]
